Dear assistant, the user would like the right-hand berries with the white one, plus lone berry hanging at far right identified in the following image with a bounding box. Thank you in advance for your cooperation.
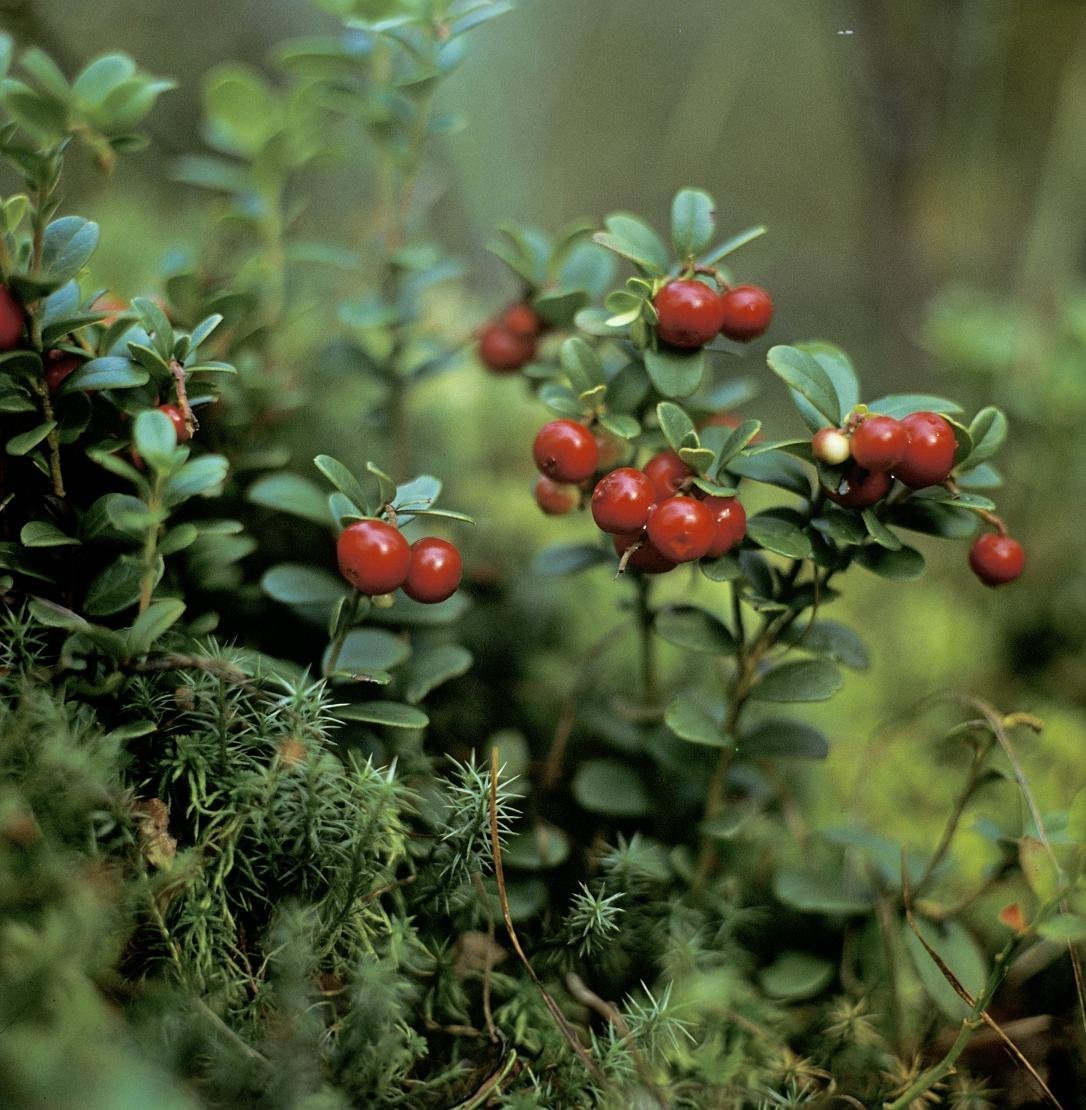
[811,412,1025,586]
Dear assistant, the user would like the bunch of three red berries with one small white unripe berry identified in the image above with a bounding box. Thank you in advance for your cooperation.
[811,412,957,508]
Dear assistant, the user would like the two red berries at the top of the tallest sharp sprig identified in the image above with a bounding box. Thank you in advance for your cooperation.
[652,279,773,350]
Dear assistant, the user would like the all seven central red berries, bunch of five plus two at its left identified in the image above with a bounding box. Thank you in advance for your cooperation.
[533,420,746,574]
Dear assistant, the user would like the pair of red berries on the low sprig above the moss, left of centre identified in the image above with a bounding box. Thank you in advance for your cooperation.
[335,519,463,605]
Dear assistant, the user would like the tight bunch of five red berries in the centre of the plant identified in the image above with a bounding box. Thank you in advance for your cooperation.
[592,451,746,574]
